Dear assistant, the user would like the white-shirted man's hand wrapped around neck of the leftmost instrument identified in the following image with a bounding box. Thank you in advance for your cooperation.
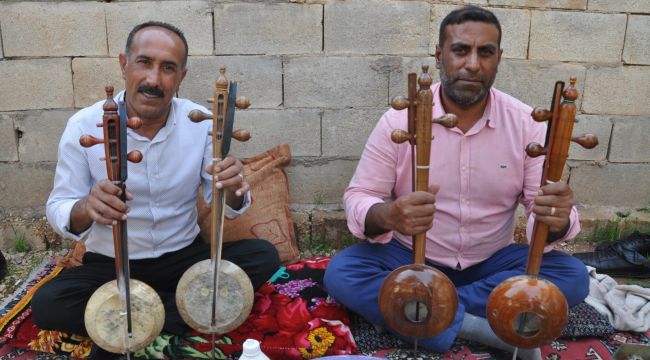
[70,179,133,234]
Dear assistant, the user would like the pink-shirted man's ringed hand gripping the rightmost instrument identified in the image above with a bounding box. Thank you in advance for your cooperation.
[533,181,573,233]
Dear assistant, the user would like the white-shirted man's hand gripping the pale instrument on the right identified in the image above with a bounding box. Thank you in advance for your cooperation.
[205,155,250,210]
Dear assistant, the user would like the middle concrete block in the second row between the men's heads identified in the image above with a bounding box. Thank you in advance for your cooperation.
[284,57,388,109]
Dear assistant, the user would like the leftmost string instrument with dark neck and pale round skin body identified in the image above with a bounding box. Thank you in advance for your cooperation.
[79,86,165,357]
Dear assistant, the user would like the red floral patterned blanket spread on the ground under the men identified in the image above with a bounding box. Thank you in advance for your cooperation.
[0,257,650,360]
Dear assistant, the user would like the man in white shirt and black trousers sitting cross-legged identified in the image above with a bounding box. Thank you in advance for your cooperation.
[32,21,280,334]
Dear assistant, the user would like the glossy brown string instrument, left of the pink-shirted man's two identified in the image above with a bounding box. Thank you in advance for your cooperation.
[379,65,458,340]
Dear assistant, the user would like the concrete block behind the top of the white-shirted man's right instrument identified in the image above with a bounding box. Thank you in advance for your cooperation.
[179,56,282,109]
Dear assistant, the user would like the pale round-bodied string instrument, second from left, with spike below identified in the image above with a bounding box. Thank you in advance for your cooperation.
[176,66,254,346]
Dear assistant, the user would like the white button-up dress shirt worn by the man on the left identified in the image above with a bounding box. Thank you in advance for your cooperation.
[46,91,250,259]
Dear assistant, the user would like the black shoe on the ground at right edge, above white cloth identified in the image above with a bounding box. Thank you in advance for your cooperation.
[573,244,650,278]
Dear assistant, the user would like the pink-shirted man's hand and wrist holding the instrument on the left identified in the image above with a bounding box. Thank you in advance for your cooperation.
[365,185,439,236]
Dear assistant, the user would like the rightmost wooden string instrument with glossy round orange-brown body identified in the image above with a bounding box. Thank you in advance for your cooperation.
[487,77,598,348]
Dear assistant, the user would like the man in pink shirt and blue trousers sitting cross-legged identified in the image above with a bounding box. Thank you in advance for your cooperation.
[325,6,589,359]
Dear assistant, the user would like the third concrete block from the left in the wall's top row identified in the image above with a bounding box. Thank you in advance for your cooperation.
[214,2,323,55]
